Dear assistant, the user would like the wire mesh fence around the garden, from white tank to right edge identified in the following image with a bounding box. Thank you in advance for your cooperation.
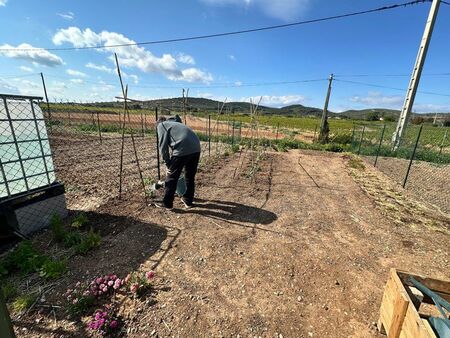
[0,91,450,239]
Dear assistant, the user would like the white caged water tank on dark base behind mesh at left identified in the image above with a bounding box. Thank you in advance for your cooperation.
[0,95,67,236]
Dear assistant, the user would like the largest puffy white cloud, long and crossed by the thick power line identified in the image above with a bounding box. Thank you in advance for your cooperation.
[52,27,213,83]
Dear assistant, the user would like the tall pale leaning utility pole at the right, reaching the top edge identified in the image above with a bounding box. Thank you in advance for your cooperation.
[392,0,441,150]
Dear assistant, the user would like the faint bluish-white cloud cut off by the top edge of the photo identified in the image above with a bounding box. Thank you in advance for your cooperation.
[201,0,311,21]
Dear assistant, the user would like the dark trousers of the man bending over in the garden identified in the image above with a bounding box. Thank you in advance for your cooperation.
[163,153,200,208]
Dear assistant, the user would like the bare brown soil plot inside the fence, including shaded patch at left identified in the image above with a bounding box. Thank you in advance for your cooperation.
[8,151,450,337]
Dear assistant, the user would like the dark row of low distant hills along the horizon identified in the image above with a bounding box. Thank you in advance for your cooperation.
[93,97,450,120]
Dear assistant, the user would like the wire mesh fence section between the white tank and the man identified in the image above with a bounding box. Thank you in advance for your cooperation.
[43,102,157,210]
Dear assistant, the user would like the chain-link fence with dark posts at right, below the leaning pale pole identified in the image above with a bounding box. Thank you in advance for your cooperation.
[351,124,450,212]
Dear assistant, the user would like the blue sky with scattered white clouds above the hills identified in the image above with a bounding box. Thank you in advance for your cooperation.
[0,0,450,112]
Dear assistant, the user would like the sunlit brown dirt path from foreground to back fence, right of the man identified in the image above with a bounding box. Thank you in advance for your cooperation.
[96,152,449,337]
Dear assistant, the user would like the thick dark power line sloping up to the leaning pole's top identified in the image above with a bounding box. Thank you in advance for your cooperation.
[0,0,432,51]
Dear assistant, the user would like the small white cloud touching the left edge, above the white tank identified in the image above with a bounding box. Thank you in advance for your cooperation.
[0,43,63,67]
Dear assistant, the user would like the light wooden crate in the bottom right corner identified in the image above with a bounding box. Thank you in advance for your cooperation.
[378,269,450,338]
